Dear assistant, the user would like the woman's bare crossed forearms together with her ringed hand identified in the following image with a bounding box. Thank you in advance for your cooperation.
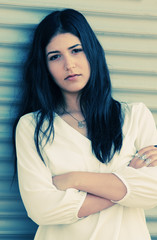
[53,146,157,217]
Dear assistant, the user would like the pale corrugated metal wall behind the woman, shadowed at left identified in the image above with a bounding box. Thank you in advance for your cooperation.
[0,0,157,240]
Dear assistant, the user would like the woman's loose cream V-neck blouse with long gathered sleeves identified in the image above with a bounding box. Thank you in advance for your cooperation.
[16,103,157,240]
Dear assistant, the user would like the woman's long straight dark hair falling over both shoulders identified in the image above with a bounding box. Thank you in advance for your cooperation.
[14,9,123,167]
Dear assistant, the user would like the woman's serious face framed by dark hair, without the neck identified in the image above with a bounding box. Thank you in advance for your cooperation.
[46,33,90,95]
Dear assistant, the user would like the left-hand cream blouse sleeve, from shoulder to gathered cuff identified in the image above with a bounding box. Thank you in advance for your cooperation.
[16,115,86,225]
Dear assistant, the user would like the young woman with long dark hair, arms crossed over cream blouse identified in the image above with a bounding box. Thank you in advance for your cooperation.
[16,9,157,240]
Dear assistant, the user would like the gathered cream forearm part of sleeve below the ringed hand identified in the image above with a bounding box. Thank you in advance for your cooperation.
[114,167,157,209]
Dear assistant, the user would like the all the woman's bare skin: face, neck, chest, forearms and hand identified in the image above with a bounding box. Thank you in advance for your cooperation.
[45,33,157,217]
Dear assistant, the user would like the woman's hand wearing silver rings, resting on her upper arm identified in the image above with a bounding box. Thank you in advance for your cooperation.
[129,145,157,168]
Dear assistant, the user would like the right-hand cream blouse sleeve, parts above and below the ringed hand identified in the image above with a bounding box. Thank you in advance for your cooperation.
[114,103,157,209]
